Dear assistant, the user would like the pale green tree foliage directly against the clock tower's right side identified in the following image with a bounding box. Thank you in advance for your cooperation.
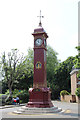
[47,46,59,84]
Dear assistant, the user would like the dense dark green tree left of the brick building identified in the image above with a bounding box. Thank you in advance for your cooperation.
[55,56,75,92]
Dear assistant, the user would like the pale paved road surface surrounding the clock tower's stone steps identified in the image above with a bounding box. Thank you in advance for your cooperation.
[0,101,79,118]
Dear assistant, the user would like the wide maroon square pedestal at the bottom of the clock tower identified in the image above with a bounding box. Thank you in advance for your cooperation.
[27,88,53,108]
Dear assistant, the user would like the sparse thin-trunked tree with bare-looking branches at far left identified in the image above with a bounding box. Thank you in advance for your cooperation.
[1,49,24,96]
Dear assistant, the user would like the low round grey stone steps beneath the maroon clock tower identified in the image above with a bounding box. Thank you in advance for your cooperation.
[13,106,62,115]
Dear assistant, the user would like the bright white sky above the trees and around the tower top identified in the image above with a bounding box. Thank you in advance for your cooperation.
[0,0,79,61]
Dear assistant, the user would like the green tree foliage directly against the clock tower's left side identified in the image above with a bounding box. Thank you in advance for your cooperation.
[14,48,34,90]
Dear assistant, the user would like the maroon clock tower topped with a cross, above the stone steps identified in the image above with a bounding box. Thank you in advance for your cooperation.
[27,11,53,108]
